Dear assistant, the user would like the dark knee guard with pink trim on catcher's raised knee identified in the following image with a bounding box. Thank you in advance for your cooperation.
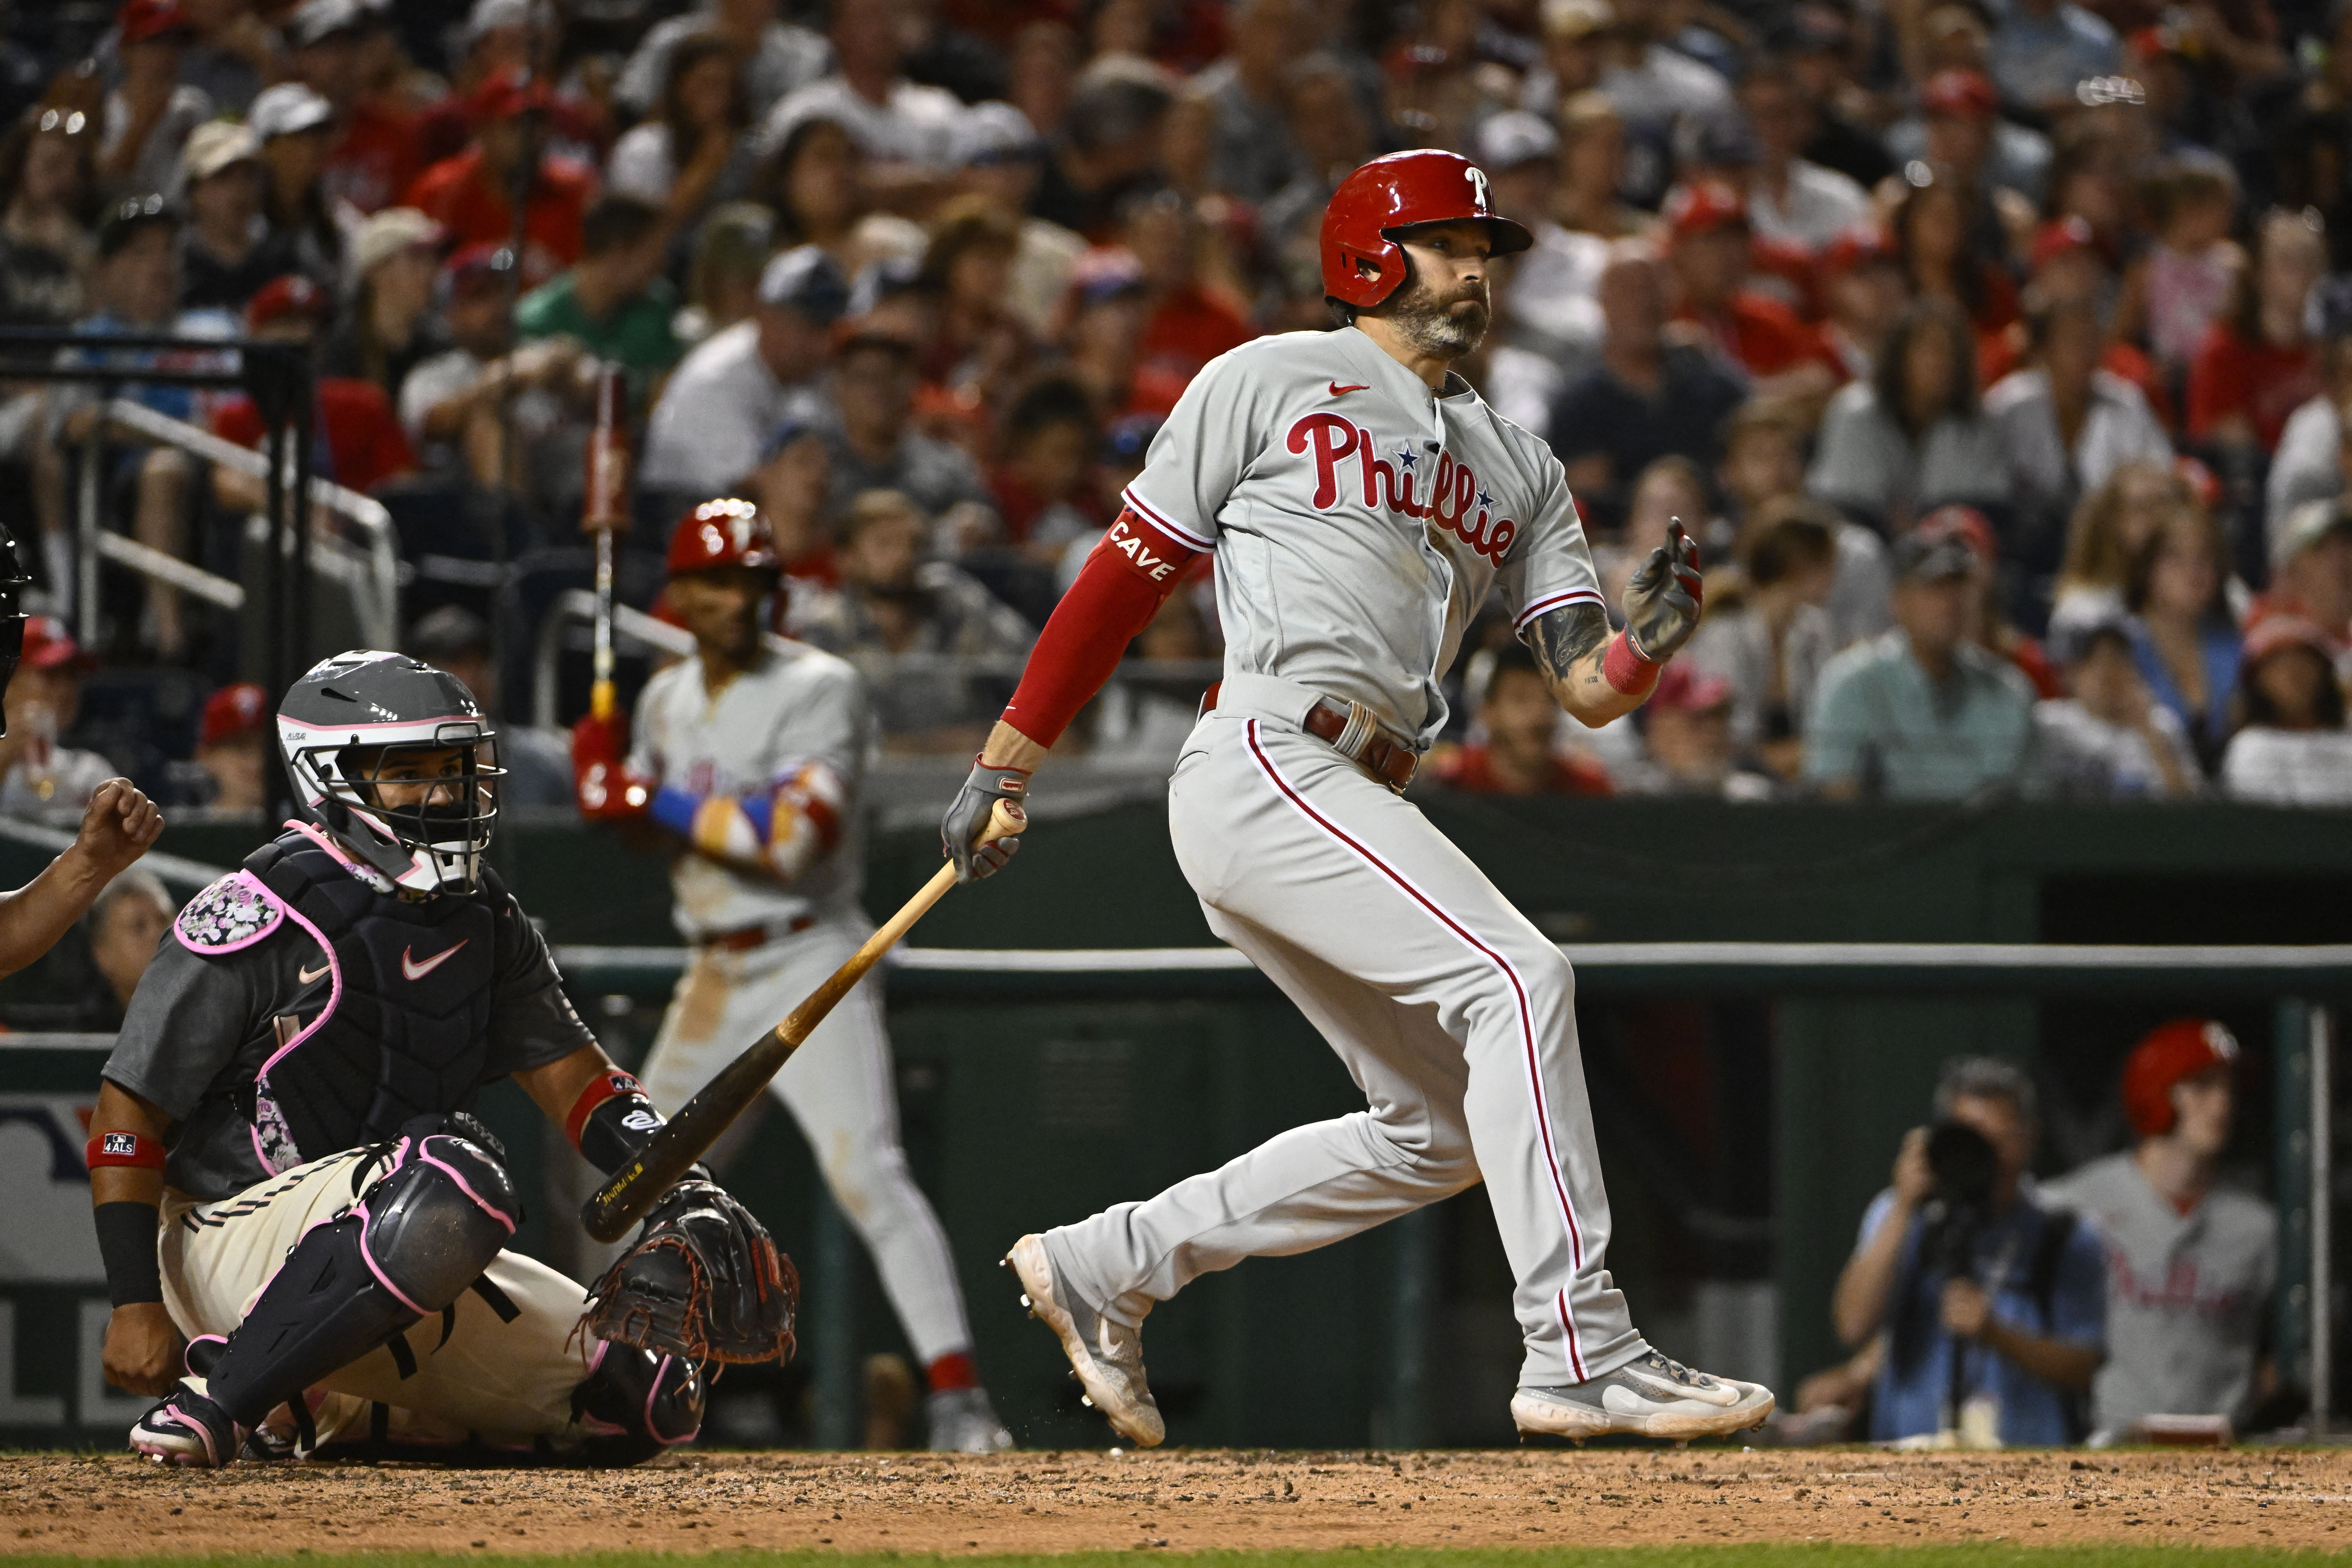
[353,1131,522,1314]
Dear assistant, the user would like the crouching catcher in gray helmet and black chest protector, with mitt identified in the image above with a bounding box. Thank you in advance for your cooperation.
[87,651,797,1464]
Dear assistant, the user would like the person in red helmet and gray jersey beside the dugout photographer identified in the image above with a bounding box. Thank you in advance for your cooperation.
[2042,1018,2279,1446]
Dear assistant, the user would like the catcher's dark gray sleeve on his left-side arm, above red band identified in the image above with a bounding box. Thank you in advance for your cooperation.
[104,933,282,1121]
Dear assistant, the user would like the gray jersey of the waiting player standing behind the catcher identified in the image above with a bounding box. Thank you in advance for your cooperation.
[628,642,872,945]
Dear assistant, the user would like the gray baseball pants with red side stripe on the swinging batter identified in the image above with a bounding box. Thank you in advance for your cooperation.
[1047,677,1649,1387]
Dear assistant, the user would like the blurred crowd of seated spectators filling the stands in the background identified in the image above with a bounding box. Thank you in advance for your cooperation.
[0,0,2352,809]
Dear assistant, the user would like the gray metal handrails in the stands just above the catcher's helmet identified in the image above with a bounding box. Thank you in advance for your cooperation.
[92,397,400,649]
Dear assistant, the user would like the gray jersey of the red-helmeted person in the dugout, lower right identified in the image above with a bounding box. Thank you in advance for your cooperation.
[2042,1152,2279,1436]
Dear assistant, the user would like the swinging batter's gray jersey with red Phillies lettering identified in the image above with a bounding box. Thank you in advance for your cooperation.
[1127,327,1602,750]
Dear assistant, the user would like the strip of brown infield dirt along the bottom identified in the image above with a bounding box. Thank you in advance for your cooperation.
[0,1448,2352,1556]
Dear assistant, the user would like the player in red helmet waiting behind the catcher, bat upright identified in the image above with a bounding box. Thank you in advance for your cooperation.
[574,501,1014,1453]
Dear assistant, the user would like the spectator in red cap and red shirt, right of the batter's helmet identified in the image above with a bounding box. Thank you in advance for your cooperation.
[1665,179,1842,400]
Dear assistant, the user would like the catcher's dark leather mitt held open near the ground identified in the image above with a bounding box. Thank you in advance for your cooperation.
[583,1180,800,1361]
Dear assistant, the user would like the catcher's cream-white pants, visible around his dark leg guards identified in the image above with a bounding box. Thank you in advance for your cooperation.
[160,1150,597,1446]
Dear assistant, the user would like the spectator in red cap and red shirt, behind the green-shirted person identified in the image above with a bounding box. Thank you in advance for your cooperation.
[402,70,595,287]
